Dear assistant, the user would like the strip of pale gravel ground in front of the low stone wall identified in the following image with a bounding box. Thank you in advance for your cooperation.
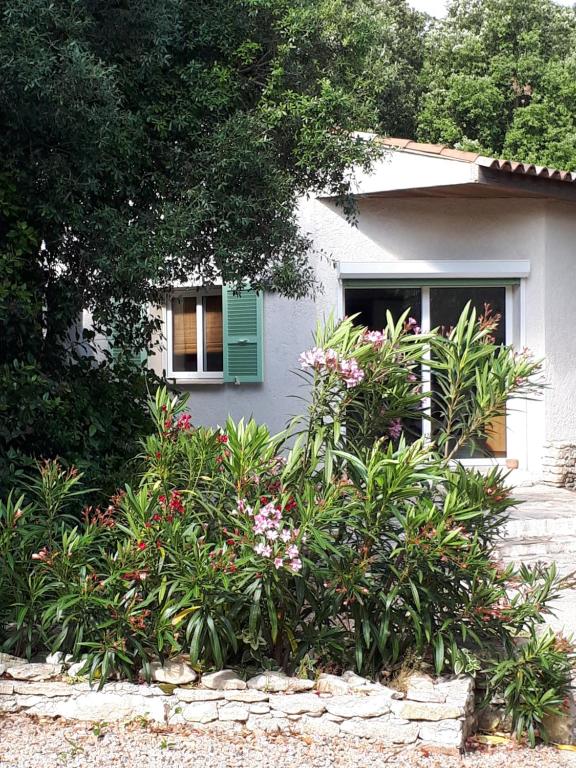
[0,715,576,768]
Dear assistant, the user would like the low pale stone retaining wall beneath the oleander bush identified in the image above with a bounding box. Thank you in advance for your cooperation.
[0,654,474,749]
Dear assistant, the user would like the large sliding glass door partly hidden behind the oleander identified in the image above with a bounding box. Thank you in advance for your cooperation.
[344,280,518,458]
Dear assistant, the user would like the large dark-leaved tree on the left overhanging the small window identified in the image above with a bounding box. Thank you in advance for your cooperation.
[0,0,394,492]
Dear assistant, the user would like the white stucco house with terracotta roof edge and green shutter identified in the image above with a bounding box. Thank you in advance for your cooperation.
[151,139,576,486]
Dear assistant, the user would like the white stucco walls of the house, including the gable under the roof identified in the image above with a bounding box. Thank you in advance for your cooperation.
[146,152,576,480]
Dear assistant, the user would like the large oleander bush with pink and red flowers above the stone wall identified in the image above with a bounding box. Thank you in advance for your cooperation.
[0,308,568,744]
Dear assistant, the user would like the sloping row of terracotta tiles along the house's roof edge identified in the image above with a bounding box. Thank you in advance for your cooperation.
[378,137,576,183]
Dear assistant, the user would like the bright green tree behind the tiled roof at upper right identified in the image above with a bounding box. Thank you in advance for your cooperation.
[418,0,576,168]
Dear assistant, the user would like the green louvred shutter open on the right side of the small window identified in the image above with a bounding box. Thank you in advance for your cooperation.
[222,286,264,383]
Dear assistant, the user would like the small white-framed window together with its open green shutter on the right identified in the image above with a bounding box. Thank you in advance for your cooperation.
[166,286,263,384]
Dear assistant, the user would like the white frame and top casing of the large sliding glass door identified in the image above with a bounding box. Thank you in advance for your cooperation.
[337,259,531,469]
